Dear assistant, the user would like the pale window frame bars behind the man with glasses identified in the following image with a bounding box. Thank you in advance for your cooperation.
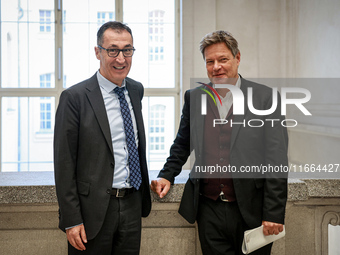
[0,0,181,172]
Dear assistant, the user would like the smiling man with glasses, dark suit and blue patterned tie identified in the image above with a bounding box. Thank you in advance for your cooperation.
[54,22,151,255]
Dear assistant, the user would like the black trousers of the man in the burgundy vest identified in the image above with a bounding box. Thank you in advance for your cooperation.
[197,196,272,255]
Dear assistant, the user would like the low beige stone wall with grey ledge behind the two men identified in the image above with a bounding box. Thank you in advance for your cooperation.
[0,172,340,255]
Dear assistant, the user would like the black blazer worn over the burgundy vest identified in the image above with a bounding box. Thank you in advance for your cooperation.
[159,77,288,228]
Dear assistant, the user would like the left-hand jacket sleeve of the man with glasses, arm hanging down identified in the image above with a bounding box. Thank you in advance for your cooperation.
[54,90,83,231]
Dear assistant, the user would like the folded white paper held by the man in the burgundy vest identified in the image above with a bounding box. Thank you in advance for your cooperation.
[242,225,286,254]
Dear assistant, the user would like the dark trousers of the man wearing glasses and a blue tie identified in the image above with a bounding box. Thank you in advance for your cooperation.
[68,191,142,255]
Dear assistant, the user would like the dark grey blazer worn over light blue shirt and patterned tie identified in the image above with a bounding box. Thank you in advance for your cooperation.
[54,74,151,240]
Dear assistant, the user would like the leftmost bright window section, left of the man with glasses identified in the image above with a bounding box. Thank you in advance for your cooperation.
[0,0,56,172]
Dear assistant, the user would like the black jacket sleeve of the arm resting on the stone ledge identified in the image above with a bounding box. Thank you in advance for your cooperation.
[158,90,191,183]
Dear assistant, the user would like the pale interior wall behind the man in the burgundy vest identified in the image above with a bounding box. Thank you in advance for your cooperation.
[181,0,340,169]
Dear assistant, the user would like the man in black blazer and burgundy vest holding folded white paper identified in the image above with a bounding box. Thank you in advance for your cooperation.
[151,31,288,255]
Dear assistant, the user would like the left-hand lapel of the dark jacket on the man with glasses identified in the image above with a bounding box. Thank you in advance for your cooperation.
[86,74,113,155]
